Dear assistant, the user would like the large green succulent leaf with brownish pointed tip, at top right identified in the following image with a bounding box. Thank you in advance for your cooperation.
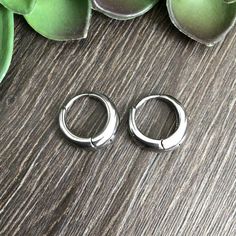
[167,0,236,46]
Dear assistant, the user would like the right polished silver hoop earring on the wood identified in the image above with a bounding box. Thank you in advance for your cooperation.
[129,95,187,152]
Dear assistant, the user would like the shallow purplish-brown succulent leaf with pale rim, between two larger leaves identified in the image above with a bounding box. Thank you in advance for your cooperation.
[93,0,159,20]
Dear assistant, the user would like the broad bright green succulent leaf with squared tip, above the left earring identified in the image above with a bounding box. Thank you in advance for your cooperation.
[25,0,91,41]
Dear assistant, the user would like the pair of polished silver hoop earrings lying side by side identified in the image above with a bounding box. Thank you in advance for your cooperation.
[59,93,187,152]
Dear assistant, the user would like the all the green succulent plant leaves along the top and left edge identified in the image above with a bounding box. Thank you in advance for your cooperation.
[0,0,236,82]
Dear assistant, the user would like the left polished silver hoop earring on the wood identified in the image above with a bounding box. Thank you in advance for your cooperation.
[59,93,120,150]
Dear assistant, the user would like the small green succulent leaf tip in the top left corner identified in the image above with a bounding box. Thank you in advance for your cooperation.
[0,0,36,15]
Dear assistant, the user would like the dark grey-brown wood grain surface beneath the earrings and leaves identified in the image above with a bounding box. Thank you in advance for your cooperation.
[0,6,236,236]
